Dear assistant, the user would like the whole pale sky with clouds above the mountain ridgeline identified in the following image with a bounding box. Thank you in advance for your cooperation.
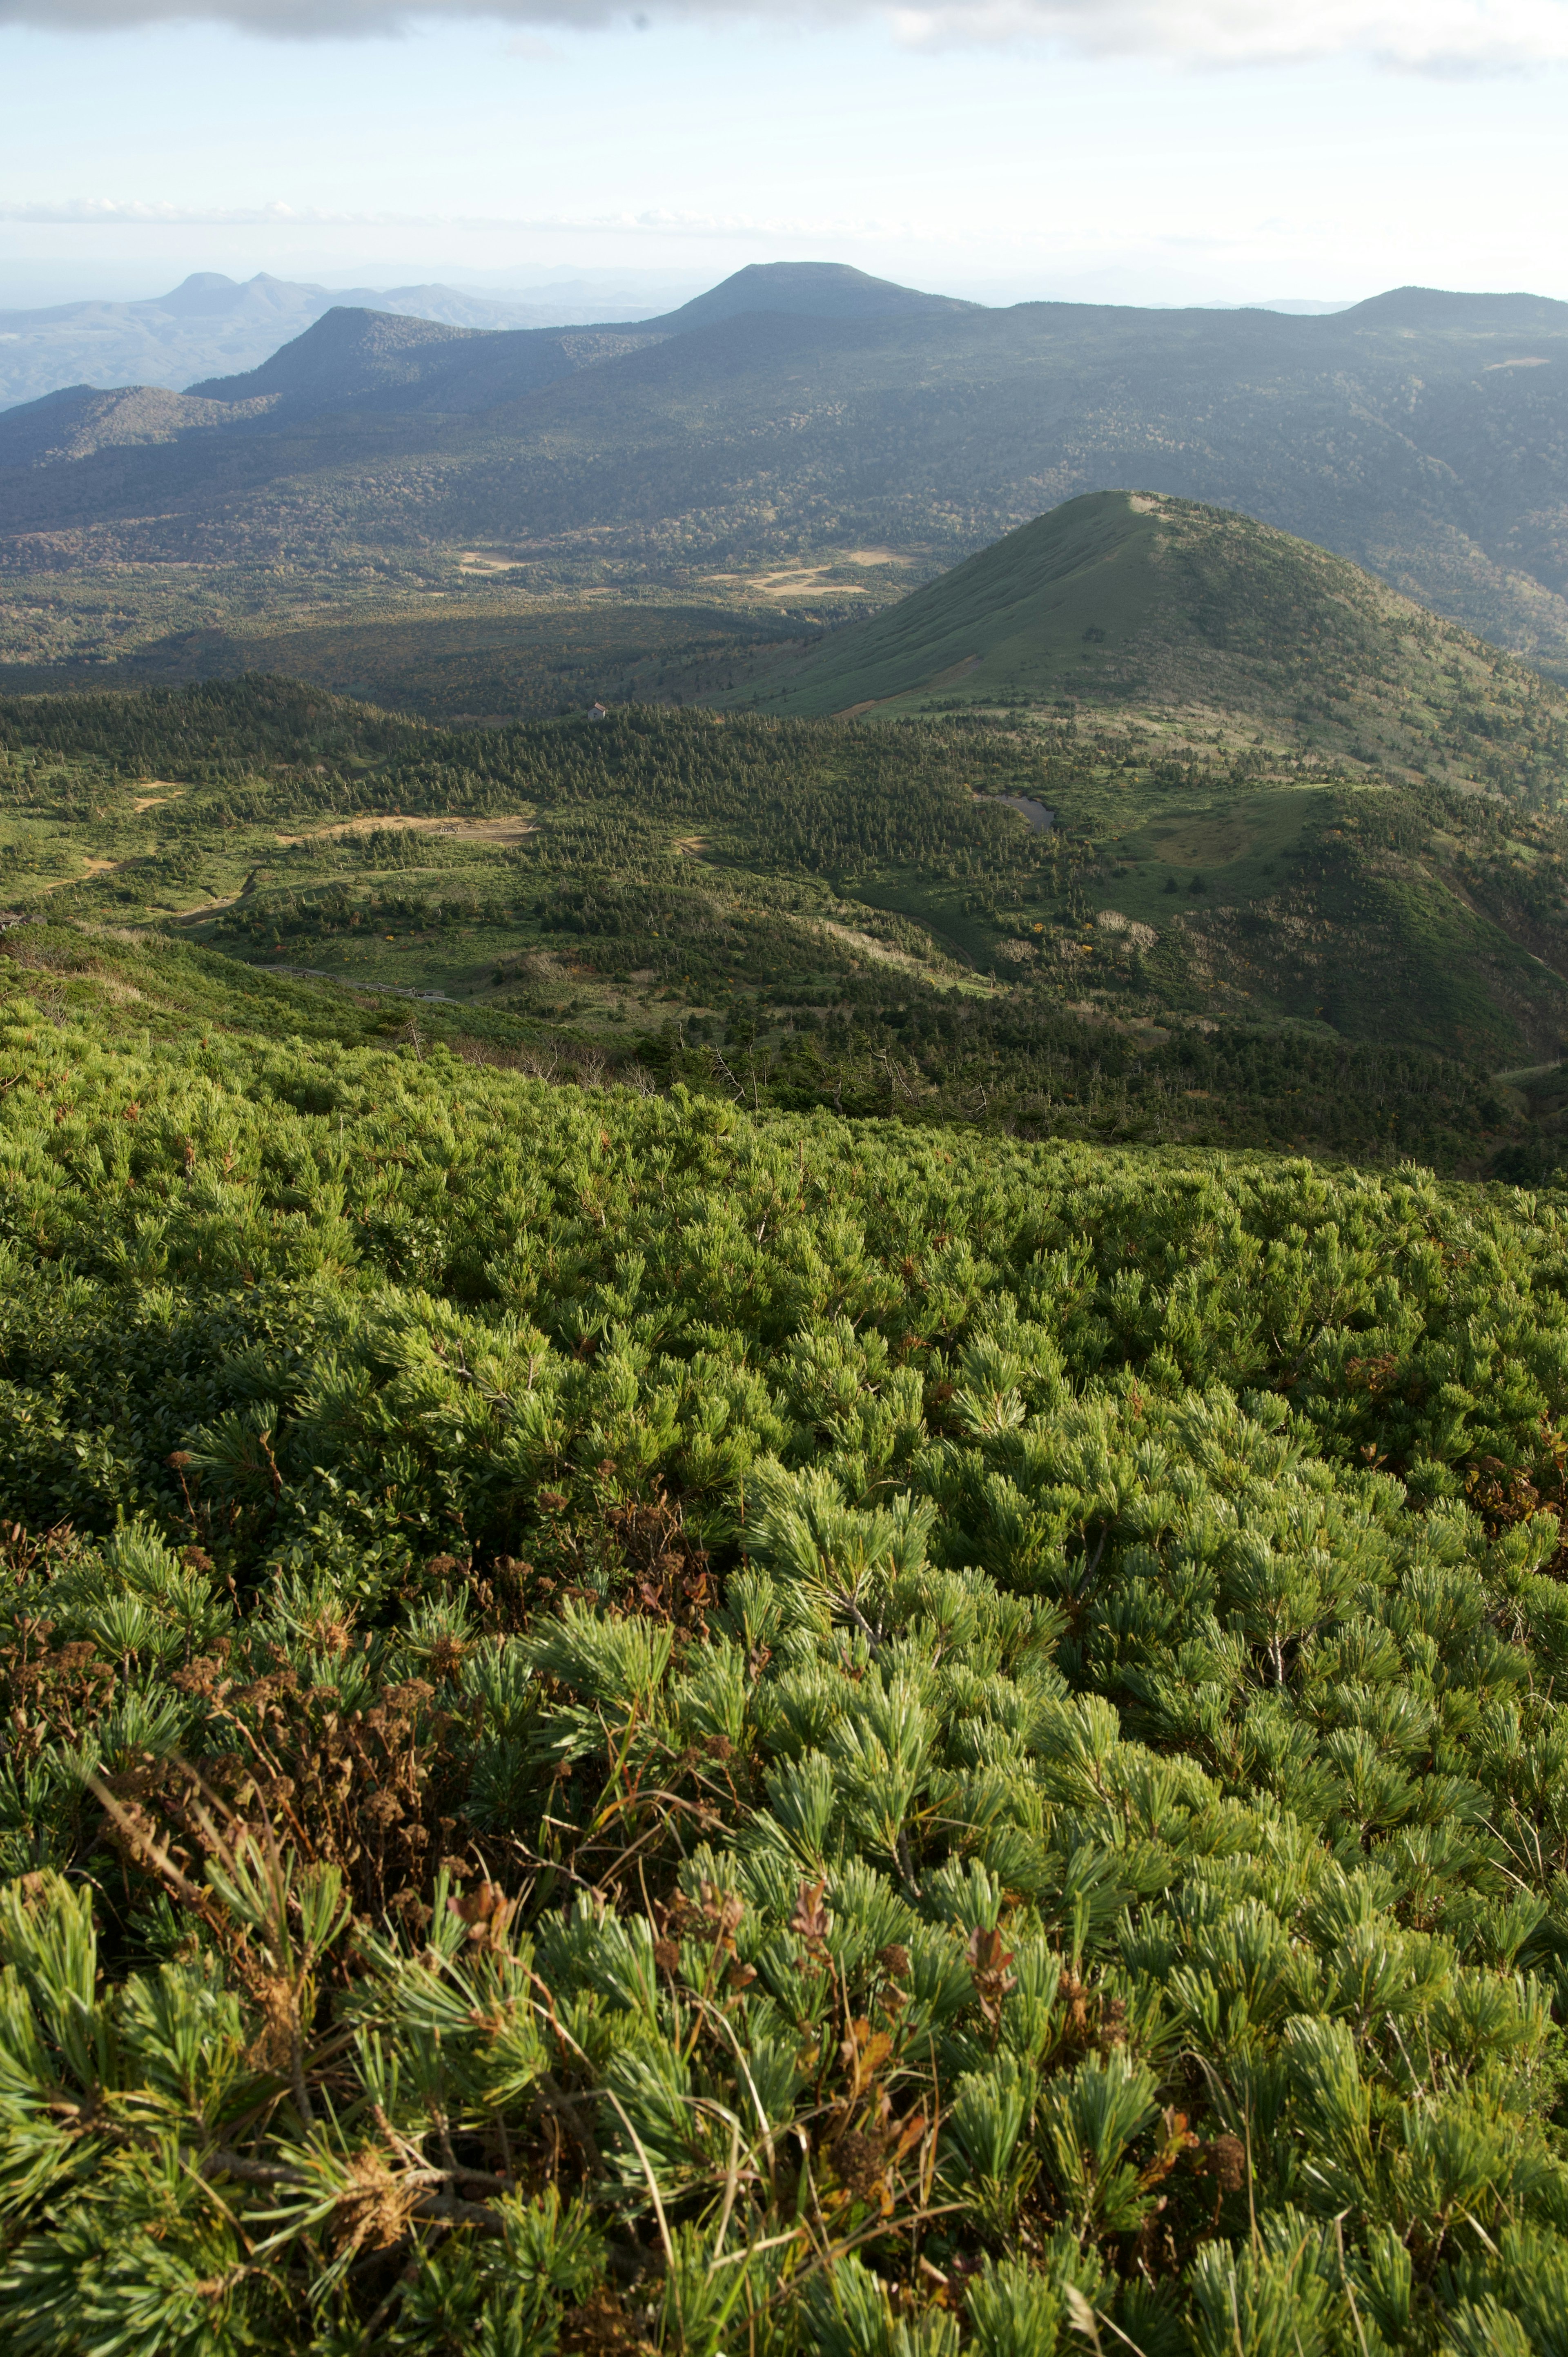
[0,0,1568,302]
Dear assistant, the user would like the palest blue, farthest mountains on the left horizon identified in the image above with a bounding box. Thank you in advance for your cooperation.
[0,271,698,410]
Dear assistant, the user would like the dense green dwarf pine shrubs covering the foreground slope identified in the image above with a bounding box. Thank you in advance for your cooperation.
[0,980,1568,2357]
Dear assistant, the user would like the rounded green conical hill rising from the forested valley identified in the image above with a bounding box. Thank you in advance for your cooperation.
[731,490,1568,801]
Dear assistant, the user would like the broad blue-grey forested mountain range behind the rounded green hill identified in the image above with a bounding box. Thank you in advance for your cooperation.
[0,264,1568,669]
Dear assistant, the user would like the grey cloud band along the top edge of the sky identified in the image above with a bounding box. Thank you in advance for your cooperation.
[0,0,1568,73]
